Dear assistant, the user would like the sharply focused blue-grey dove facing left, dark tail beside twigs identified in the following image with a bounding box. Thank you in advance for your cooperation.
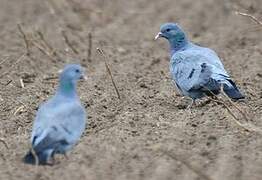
[155,23,244,105]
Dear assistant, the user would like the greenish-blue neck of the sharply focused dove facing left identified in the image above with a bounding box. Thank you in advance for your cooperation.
[169,34,189,56]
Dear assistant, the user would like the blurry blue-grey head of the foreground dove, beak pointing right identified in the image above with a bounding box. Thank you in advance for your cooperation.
[60,64,86,84]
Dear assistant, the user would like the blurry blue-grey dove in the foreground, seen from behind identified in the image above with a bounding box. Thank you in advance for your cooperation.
[24,64,86,164]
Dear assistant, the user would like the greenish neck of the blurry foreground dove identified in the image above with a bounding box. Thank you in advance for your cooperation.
[57,80,78,98]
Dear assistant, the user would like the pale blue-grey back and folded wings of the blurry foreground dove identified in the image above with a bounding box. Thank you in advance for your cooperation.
[31,102,85,151]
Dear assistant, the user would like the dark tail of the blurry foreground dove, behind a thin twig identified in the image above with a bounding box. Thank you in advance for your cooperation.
[23,150,49,165]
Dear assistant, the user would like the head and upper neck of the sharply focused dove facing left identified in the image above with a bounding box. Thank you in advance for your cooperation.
[155,23,187,50]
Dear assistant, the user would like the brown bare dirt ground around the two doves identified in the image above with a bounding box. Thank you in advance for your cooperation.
[0,0,262,180]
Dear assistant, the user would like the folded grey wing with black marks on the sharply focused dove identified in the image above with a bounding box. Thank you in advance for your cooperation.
[170,50,229,92]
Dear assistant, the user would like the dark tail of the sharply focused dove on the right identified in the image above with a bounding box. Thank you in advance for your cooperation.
[223,79,245,100]
